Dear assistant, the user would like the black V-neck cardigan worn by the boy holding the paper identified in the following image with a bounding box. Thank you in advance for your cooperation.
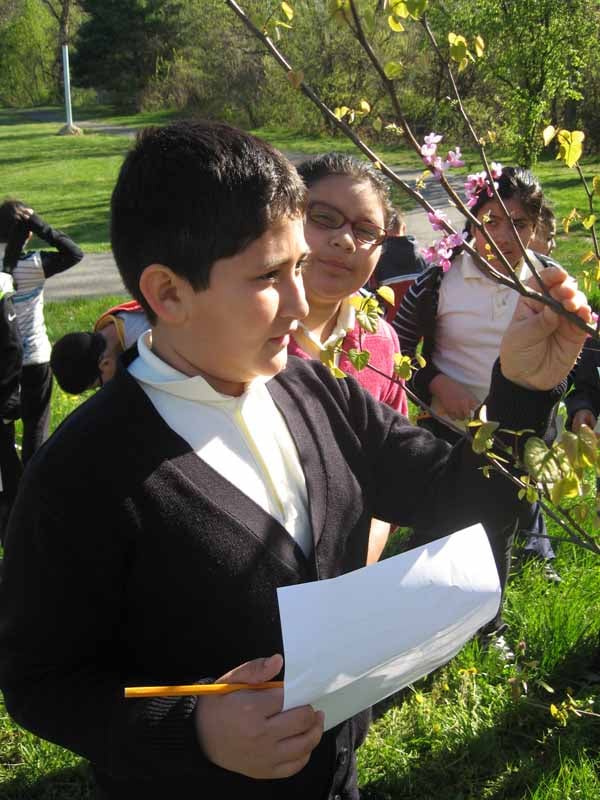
[0,358,554,800]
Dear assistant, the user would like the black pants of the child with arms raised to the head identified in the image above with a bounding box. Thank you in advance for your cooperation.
[21,363,52,464]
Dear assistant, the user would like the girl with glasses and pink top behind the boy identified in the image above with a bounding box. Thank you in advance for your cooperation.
[288,153,408,563]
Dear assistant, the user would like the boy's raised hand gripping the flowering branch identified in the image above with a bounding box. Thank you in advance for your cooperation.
[500,267,592,391]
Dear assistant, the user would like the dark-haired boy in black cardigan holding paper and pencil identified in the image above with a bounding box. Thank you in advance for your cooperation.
[0,122,589,800]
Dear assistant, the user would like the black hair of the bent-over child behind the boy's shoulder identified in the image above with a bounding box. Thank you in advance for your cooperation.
[50,333,106,394]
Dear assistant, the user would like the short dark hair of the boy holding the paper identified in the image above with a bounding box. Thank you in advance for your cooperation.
[111,121,306,322]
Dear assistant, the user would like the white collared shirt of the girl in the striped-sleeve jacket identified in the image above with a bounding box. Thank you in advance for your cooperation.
[432,251,535,413]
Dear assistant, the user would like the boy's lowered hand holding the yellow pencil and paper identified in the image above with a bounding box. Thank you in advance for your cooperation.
[196,655,324,779]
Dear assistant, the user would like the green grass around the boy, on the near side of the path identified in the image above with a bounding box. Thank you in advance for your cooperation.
[0,297,600,800]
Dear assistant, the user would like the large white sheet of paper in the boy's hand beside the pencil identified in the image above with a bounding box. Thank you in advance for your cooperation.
[277,525,500,730]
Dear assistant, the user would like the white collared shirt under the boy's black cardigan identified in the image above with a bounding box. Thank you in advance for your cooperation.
[128,331,313,556]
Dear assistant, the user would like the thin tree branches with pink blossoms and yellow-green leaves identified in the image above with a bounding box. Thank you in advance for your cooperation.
[225,0,600,555]
